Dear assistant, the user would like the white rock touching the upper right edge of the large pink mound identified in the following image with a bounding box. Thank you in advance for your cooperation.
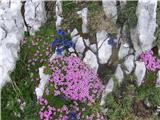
[83,50,99,72]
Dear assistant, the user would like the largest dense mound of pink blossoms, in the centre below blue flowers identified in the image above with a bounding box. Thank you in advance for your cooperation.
[50,55,104,103]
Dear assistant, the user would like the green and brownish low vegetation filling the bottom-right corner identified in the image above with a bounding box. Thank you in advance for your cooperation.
[106,72,160,120]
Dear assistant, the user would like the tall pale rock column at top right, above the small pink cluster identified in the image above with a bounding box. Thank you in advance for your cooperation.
[137,0,157,51]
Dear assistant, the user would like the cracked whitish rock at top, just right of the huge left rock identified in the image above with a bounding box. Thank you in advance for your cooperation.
[25,0,47,35]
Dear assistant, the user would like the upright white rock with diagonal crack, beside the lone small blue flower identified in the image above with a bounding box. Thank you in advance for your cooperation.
[96,31,112,64]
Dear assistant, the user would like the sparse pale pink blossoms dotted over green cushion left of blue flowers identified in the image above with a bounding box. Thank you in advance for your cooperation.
[21,37,52,81]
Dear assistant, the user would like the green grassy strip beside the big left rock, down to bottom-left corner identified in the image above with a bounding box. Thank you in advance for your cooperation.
[1,21,55,120]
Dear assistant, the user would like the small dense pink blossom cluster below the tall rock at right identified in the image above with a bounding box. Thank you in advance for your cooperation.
[140,50,160,71]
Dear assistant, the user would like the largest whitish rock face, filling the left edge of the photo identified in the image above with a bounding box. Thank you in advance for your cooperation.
[0,0,25,89]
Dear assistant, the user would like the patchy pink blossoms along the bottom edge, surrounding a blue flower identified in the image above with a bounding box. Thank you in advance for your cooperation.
[39,99,105,120]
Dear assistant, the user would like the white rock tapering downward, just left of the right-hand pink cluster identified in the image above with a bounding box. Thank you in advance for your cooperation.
[135,61,146,86]
